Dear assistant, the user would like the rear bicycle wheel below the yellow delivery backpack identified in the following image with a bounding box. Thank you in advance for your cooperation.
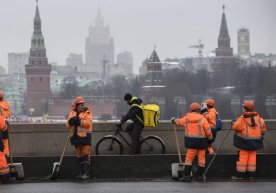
[140,135,166,154]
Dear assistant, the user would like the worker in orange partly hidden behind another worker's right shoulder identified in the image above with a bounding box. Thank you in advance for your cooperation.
[201,99,218,154]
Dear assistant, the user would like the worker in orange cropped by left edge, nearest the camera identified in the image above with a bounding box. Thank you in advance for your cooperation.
[0,116,11,183]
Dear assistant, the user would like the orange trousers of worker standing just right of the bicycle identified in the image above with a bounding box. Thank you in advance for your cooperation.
[185,148,206,167]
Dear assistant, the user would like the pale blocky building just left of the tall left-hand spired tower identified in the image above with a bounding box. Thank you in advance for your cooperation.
[8,53,30,74]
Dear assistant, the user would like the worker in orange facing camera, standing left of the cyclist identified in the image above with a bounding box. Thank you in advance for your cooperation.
[66,97,92,180]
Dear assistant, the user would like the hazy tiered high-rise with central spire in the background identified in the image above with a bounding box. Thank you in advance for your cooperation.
[83,9,114,78]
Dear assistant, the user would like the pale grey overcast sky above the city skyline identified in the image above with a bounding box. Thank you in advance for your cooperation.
[0,0,276,73]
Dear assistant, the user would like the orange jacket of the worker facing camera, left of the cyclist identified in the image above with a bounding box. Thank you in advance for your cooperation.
[66,108,93,145]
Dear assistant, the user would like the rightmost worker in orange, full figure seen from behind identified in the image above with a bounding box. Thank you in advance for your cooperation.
[231,101,266,180]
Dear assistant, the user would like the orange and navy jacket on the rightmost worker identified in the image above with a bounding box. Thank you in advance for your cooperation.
[232,112,266,151]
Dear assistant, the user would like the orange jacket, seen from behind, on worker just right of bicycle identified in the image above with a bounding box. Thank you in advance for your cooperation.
[175,112,212,149]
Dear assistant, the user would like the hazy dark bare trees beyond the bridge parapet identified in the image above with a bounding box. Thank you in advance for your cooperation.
[60,65,276,119]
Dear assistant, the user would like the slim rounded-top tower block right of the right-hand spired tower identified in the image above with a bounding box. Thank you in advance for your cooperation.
[238,28,250,57]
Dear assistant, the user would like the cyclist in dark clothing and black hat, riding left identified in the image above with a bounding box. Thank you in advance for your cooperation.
[115,93,144,154]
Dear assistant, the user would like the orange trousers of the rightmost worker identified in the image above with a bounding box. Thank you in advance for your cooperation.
[237,149,257,172]
